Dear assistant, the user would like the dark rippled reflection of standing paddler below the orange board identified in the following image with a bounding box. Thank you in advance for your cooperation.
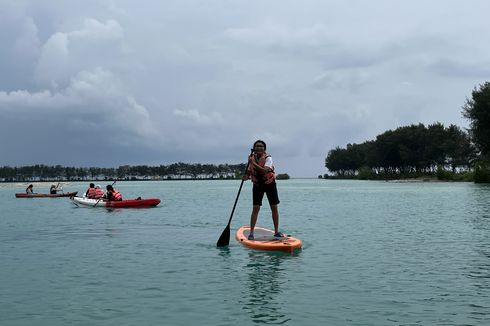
[243,251,291,324]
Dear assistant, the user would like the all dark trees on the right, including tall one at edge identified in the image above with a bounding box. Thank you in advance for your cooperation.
[325,81,490,183]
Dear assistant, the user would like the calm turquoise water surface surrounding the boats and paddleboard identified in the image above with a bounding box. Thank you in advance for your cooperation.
[0,180,490,326]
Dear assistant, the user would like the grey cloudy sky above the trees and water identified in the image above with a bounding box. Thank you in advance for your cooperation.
[0,0,490,177]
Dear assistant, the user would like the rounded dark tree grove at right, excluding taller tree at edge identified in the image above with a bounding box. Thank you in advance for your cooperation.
[325,123,475,178]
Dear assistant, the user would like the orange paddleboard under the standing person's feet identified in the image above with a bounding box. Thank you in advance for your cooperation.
[235,226,302,252]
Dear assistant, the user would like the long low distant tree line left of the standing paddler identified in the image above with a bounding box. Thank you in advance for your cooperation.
[0,162,245,182]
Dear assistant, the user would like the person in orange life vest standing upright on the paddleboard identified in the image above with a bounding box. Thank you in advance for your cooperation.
[244,140,284,240]
